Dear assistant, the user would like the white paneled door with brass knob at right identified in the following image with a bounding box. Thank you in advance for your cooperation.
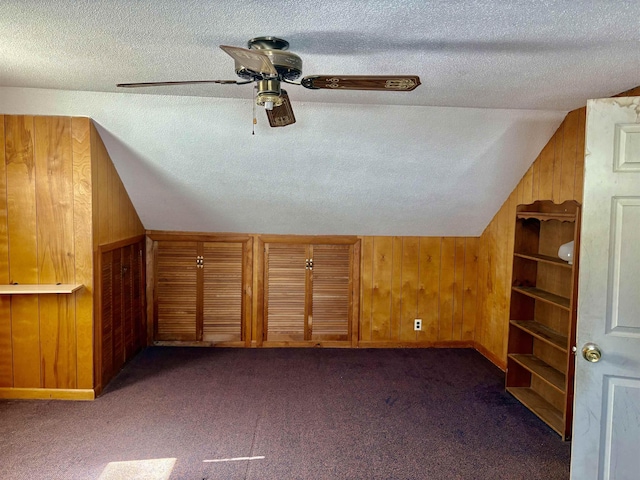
[571,97,640,480]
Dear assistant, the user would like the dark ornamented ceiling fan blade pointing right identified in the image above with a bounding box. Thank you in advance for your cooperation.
[300,75,420,92]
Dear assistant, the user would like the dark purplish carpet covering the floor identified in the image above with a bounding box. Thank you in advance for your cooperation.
[0,347,570,480]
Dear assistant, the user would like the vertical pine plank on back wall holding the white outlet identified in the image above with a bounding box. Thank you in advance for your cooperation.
[399,237,420,342]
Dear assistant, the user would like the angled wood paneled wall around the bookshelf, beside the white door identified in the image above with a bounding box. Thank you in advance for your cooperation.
[475,87,640,369]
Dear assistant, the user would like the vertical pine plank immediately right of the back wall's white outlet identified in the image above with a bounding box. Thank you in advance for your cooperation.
[417,237,442,342]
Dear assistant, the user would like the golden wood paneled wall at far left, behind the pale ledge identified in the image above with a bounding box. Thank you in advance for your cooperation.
[0,115,144,398]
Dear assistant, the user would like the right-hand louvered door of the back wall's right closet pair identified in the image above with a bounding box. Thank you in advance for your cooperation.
[310,245,353,341]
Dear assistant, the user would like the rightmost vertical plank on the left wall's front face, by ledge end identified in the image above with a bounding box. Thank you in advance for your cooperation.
[71,118,94,389]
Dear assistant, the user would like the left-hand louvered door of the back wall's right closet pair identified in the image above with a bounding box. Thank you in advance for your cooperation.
[265,243,309,341]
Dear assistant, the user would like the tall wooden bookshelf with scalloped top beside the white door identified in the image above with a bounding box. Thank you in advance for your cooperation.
[505,201,580,440]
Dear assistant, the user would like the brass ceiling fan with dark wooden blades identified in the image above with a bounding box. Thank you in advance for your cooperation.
[117,37,420,127]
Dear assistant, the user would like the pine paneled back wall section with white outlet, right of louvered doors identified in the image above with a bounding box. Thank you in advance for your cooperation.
[359,237,479,347]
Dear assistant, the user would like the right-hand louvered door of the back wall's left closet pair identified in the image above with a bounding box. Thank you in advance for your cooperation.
[202,242,243,342]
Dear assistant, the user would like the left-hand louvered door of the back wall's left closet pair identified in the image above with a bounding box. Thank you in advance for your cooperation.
[155,241,198,341]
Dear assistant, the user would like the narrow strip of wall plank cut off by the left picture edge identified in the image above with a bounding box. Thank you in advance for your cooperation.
[0,115,13,387]
